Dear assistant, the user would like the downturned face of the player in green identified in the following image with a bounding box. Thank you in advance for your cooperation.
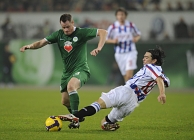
[60,21,74,35]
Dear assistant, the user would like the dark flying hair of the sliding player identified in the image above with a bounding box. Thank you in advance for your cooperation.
[147,46,165,66]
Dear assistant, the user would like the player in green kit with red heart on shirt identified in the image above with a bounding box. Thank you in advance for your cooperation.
[20,14,107,118]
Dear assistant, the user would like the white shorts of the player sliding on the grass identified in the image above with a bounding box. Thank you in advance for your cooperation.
[100,86,139,122]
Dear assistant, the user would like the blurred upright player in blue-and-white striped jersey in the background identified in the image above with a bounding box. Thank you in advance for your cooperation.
[106,8,141,82]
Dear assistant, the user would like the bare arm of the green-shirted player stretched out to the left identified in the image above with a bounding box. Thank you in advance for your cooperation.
[20,39,48,52]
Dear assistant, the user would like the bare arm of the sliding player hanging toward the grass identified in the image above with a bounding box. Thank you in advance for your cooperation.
[156,77,166,104]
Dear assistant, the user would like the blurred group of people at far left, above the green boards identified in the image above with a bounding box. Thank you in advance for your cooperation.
[0,16,54,43]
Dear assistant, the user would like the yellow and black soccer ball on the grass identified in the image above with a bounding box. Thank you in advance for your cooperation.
[45,116,62,131]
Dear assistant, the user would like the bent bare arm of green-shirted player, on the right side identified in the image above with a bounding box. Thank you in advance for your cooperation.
[90,29,107,56]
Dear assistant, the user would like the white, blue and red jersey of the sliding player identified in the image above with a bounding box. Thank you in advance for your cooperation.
[126,64,170,101]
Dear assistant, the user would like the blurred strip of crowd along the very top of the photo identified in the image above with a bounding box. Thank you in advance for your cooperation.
[0,0,194,12]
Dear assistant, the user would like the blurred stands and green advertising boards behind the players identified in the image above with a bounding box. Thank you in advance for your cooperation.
[0,0,194,89]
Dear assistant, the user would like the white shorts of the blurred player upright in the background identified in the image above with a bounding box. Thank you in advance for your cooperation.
[115,51,137,75]
